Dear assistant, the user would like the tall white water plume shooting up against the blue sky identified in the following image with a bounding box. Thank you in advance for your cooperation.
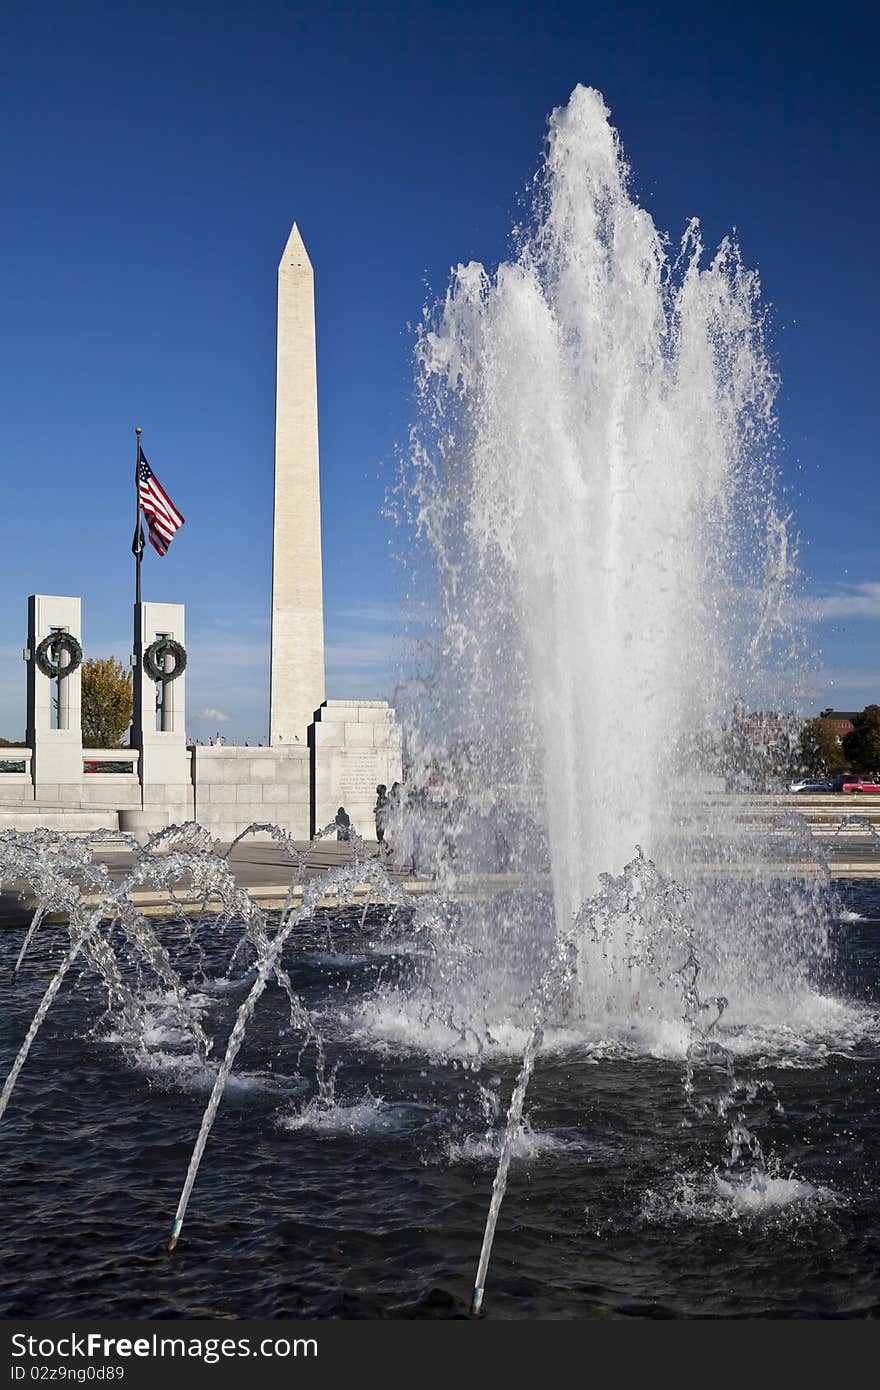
[406,86,792,924]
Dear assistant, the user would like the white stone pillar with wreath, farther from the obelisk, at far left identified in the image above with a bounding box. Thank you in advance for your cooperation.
[25,594,82,803]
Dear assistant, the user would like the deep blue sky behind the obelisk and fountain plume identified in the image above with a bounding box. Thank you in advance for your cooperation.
[0,0,880,739]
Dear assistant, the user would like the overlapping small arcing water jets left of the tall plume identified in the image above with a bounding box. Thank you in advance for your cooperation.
[0,823,406,1248]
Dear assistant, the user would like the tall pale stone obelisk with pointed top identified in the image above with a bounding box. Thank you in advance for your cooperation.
[268,222,324,746]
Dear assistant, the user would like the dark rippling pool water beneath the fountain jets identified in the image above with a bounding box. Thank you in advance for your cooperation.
[0,883,880,1318]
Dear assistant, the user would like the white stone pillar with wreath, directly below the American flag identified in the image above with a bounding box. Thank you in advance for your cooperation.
[132,603,193,828]
